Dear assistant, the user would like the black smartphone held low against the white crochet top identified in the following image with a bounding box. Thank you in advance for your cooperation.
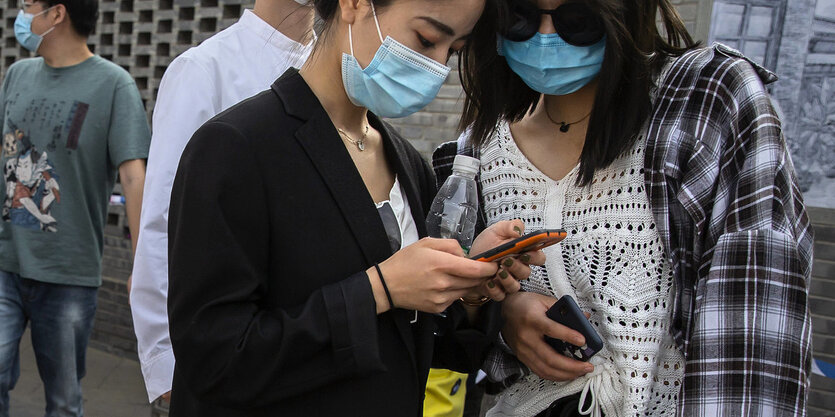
[545,295,603,362]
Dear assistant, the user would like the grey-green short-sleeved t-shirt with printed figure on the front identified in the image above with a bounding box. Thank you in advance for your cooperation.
[0,56,151,287]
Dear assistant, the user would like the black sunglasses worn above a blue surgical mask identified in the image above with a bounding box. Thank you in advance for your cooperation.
[500,0,605,46]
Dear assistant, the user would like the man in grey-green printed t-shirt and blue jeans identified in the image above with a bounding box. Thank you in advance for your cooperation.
[0,0,150,417]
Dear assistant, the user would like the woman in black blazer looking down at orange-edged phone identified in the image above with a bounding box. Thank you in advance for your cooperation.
[169,0,544,417]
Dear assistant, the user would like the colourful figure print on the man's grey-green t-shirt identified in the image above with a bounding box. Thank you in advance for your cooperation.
[2,129,61,232]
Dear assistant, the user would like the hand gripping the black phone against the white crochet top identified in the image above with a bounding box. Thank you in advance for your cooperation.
[502,292,594,381]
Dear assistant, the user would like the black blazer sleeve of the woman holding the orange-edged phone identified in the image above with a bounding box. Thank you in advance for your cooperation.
[168,121,382,408]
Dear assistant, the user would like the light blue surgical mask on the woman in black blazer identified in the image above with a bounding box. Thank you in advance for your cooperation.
[342,3,449,117]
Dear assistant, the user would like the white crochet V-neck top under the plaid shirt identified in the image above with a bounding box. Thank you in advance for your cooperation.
[480,123,684,417]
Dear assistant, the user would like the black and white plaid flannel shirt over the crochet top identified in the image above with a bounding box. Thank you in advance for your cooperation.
[433,44,812,417]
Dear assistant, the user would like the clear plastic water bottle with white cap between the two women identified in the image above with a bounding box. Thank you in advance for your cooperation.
[426,155,479,253]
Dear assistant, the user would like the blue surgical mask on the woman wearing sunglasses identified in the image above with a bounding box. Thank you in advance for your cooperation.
[499,33,606,96]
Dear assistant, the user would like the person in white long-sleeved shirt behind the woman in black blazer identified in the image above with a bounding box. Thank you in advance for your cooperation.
[128,0,315,402]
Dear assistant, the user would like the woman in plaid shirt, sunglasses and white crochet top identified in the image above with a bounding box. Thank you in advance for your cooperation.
[433,0,813,416]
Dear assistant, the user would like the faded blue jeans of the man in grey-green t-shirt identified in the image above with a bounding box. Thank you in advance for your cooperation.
[0,271,98,417]
